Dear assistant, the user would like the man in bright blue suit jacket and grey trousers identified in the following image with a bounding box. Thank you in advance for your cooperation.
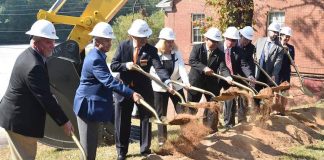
[73,22,142,160]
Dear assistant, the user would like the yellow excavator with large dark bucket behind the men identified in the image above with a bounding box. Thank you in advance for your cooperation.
[37,0,127,149]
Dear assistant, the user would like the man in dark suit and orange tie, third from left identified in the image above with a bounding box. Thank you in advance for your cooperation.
[110,19,173,159]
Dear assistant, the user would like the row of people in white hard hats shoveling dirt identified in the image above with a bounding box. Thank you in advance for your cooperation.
[0,19,294,160]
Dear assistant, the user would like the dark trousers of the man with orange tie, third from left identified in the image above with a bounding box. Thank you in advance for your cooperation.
[115,90,153,155]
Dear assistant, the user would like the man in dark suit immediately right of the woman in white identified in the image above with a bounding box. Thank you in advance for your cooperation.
[188,28,232,133]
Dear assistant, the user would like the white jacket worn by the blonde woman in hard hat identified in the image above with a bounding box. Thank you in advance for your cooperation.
[150,50,189,92]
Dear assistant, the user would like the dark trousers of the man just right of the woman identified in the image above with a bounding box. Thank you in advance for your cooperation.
[187,91,218,132]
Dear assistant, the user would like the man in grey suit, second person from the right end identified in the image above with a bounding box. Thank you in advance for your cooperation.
[255,22,284,91]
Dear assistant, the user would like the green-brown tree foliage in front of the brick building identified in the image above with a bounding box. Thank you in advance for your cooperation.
[194,0,254,33]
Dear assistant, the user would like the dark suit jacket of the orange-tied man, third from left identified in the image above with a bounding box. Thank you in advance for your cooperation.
[110,40,170,101]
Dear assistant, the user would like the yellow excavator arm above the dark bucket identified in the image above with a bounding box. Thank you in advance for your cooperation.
[37,0,127,52]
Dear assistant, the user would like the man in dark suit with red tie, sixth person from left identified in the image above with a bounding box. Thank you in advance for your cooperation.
[223,27,254,129]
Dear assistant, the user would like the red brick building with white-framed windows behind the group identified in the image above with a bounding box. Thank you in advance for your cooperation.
[159,0,324,74]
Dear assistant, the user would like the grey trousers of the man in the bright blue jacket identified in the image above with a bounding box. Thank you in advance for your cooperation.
[77,116,99,160]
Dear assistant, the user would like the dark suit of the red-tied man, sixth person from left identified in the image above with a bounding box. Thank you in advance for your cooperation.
[224,46,253,127]
